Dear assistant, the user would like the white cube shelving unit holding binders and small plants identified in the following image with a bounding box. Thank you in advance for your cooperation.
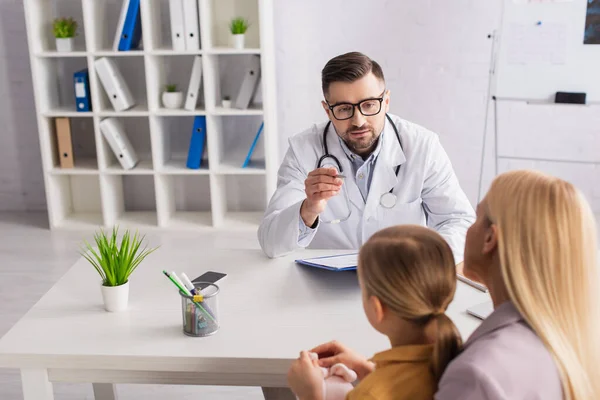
[24,0,278,229]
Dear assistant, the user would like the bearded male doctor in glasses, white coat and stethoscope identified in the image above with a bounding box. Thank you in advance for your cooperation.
[258,52,475,264]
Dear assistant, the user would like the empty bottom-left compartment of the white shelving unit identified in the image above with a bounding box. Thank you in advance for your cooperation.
[48,175,103,229]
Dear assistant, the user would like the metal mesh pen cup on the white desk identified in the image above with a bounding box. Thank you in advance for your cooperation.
[179,282,219,337]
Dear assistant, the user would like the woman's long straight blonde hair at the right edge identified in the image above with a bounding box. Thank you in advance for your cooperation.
[484,171,600,400]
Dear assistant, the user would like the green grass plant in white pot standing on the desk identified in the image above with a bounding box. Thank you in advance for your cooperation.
[81,227,157,312]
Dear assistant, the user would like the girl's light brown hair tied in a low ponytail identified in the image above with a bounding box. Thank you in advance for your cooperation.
[358,225,462,382]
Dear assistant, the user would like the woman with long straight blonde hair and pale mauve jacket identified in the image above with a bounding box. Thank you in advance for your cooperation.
[435,171,600,400]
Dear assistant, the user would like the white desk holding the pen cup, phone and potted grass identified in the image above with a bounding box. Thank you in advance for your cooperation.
[0,244,489,400]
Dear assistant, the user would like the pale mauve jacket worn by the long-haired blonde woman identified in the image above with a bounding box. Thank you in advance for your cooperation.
[435,301,563,400]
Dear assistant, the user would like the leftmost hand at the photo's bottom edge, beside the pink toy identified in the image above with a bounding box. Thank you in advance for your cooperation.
[288,351,325,400]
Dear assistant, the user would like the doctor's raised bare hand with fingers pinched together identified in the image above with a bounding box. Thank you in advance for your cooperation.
[300,168,343,226]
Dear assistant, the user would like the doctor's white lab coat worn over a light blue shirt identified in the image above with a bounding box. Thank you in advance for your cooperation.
[258,115,475,264]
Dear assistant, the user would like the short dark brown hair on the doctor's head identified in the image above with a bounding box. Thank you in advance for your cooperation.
[321,52,385,97]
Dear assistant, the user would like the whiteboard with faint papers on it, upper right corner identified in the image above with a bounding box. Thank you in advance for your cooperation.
[494,0,600,103]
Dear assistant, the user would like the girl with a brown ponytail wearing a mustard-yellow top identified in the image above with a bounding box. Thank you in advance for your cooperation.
[288,225,462,400]
